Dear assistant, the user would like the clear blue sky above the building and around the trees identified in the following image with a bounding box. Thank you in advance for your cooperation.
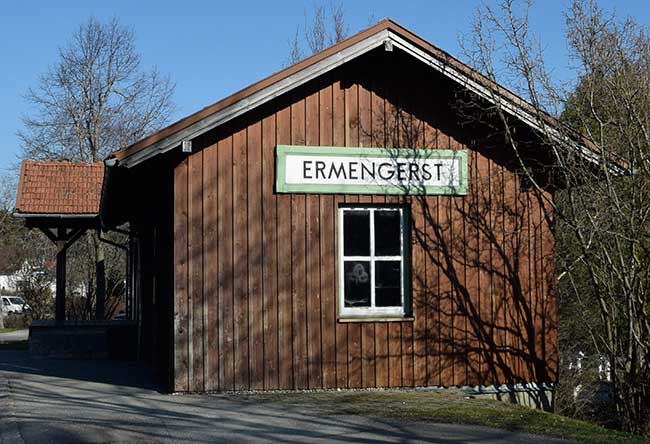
[0,0,650,173]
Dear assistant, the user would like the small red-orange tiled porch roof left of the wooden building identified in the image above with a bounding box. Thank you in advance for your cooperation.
[15,160,104,217]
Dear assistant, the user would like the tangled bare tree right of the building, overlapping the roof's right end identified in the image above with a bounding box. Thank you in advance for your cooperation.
[464,0,650,433]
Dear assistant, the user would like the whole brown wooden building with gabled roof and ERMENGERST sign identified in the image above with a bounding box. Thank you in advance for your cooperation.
[95,20,572,402]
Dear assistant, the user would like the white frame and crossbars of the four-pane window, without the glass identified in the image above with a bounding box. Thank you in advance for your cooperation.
[337,205,410,319]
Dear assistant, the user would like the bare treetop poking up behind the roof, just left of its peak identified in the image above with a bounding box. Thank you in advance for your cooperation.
[287,1,349,65]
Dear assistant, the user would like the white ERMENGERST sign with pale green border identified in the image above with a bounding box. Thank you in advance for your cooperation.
[275,145,467,195]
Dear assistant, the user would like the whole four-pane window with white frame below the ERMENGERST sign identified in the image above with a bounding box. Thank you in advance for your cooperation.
[339,206,410,318]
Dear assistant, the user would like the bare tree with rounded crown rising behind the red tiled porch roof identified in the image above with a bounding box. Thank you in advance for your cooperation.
[19,18,174,317]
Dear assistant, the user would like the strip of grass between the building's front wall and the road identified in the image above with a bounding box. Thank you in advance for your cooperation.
[236,390,650,444]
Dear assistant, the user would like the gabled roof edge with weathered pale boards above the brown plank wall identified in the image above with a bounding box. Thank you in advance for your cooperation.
[110,19,612,173]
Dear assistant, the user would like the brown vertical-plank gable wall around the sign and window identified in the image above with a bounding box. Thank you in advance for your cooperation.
[173,50,557,391]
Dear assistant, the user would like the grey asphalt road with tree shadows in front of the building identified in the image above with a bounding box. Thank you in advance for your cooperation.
[0,351,566,444]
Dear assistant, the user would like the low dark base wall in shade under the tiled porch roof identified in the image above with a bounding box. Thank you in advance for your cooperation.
[29,321,137,359]
